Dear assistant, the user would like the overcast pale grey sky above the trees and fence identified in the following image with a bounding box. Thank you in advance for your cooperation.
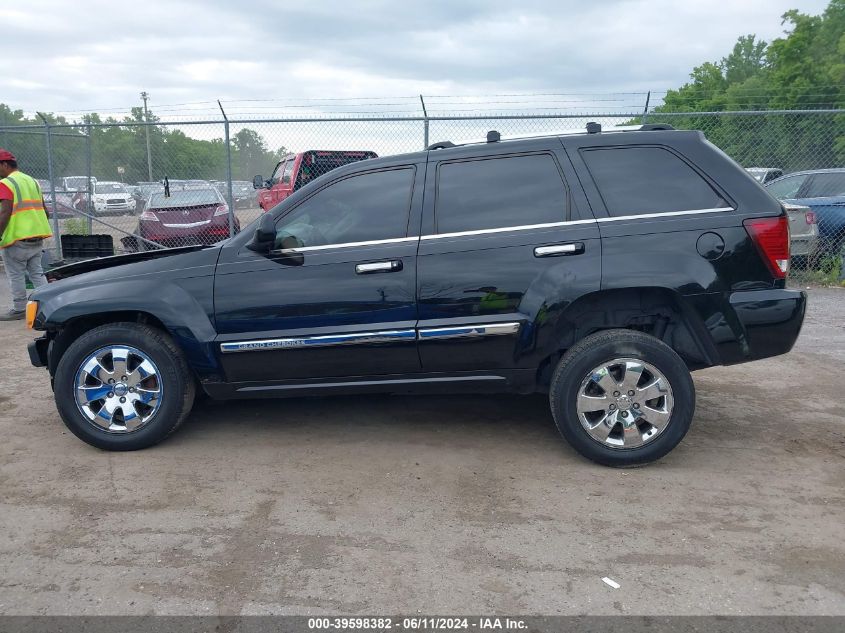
[0,0,827,118]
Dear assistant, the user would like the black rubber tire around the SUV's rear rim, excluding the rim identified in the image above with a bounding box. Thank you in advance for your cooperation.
[549,330,695,467]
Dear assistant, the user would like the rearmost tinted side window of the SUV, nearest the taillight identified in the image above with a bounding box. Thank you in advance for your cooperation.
[582,147,730,217]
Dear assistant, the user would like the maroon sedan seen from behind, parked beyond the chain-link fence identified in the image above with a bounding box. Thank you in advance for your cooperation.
[123,187,241,248]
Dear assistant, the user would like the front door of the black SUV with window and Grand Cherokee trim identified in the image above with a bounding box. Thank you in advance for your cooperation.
[214,163,425,383]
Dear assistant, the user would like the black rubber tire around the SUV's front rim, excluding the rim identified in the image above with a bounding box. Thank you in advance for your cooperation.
[53,323,195,451]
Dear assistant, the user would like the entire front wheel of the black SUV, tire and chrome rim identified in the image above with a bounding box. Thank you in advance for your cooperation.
[54,323,195,451]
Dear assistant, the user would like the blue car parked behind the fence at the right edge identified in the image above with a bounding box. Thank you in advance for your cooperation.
[766,169,845,254]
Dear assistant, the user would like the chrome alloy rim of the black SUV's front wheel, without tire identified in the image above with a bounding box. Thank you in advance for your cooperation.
[75,345,162,433]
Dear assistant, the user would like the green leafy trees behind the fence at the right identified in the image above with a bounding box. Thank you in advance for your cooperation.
[651,0,845,171]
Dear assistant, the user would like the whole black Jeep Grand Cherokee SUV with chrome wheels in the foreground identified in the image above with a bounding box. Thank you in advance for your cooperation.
[28,124,806,466]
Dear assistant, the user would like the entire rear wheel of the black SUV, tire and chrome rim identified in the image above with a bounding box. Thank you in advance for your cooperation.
[549,330,695,467]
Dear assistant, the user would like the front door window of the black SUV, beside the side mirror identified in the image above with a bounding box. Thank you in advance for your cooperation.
[275,168,414,248]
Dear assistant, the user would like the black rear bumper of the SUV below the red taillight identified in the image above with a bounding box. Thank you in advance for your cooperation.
[711,289,807,365]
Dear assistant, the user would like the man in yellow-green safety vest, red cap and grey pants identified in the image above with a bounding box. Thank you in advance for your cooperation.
[0,148,53,321]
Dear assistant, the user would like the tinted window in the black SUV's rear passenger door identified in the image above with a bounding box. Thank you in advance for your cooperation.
[435,154,567,233]
